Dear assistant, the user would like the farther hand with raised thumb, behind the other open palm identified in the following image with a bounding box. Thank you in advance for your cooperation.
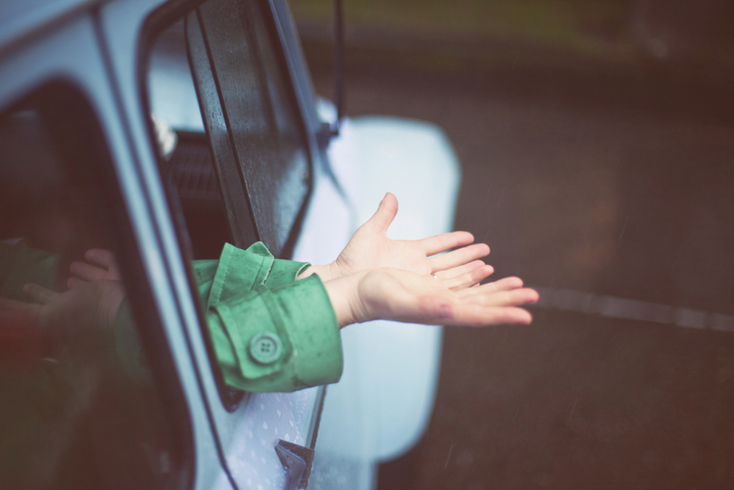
[300,192,494,284]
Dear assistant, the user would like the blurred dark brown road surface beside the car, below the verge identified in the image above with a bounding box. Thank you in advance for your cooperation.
[306,32,734,490]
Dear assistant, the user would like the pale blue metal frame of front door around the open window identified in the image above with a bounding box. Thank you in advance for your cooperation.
[98,0,334,485]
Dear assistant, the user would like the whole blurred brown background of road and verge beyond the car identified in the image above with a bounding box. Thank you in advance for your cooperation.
[291,0,734,490]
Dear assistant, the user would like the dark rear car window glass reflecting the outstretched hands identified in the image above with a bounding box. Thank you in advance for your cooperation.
[0,84,186,489]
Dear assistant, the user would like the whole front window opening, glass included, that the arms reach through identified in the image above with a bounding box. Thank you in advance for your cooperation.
[145,0,311,402]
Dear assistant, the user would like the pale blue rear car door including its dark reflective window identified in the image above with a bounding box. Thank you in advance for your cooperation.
[0,5,227,489]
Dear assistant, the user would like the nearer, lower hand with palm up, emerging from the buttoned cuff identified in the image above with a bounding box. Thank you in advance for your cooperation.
[324,269,538,328]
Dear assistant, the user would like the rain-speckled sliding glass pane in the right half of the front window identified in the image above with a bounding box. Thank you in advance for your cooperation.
[185,0,310,257]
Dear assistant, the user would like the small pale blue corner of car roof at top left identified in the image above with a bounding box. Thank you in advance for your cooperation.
[0,0,108,55]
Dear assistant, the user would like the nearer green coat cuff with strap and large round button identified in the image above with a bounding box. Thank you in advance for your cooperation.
[207,276,343,391]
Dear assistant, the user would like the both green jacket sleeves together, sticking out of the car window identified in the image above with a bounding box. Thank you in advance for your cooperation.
[194,242,343,391]
